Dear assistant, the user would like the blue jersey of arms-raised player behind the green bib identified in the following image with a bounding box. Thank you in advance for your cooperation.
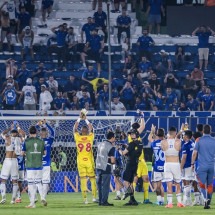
[43,123,55,166]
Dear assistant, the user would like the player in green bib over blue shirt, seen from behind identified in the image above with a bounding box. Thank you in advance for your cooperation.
[22,126,46,208]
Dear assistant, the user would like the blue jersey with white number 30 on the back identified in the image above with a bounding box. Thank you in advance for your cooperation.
[151,140,165,172]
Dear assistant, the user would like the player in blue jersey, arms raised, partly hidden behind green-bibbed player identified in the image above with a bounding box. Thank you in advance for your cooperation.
[38,120,55,206]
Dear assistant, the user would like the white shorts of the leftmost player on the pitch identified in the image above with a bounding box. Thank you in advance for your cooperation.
[1,158,19,180]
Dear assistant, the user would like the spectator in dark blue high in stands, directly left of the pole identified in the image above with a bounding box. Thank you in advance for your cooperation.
[93,6,107,43]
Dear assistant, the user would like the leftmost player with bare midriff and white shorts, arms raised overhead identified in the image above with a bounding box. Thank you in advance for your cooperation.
[0,121,24,204]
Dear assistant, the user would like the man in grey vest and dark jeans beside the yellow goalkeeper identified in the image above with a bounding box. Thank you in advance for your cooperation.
[96,131,115,206]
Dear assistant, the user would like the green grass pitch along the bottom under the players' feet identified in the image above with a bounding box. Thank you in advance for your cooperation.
[0,193,215,215]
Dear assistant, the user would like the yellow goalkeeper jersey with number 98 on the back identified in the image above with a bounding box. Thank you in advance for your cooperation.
[74,132,94,164]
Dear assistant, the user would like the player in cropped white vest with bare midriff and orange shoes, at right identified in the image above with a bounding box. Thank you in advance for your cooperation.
[161,127,184,208]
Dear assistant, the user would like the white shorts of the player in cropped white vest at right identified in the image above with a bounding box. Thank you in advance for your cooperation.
[164,162,181,183]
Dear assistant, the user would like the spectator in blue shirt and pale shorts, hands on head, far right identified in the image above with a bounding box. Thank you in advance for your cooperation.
[192,26,215,70]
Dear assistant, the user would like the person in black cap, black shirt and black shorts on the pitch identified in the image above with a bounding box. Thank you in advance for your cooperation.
[119,129,143,206]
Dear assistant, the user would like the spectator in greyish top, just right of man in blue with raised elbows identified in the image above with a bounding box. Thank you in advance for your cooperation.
[65,27,78,60]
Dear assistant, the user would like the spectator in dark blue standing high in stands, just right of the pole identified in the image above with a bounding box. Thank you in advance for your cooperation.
[116,9,131,44]
